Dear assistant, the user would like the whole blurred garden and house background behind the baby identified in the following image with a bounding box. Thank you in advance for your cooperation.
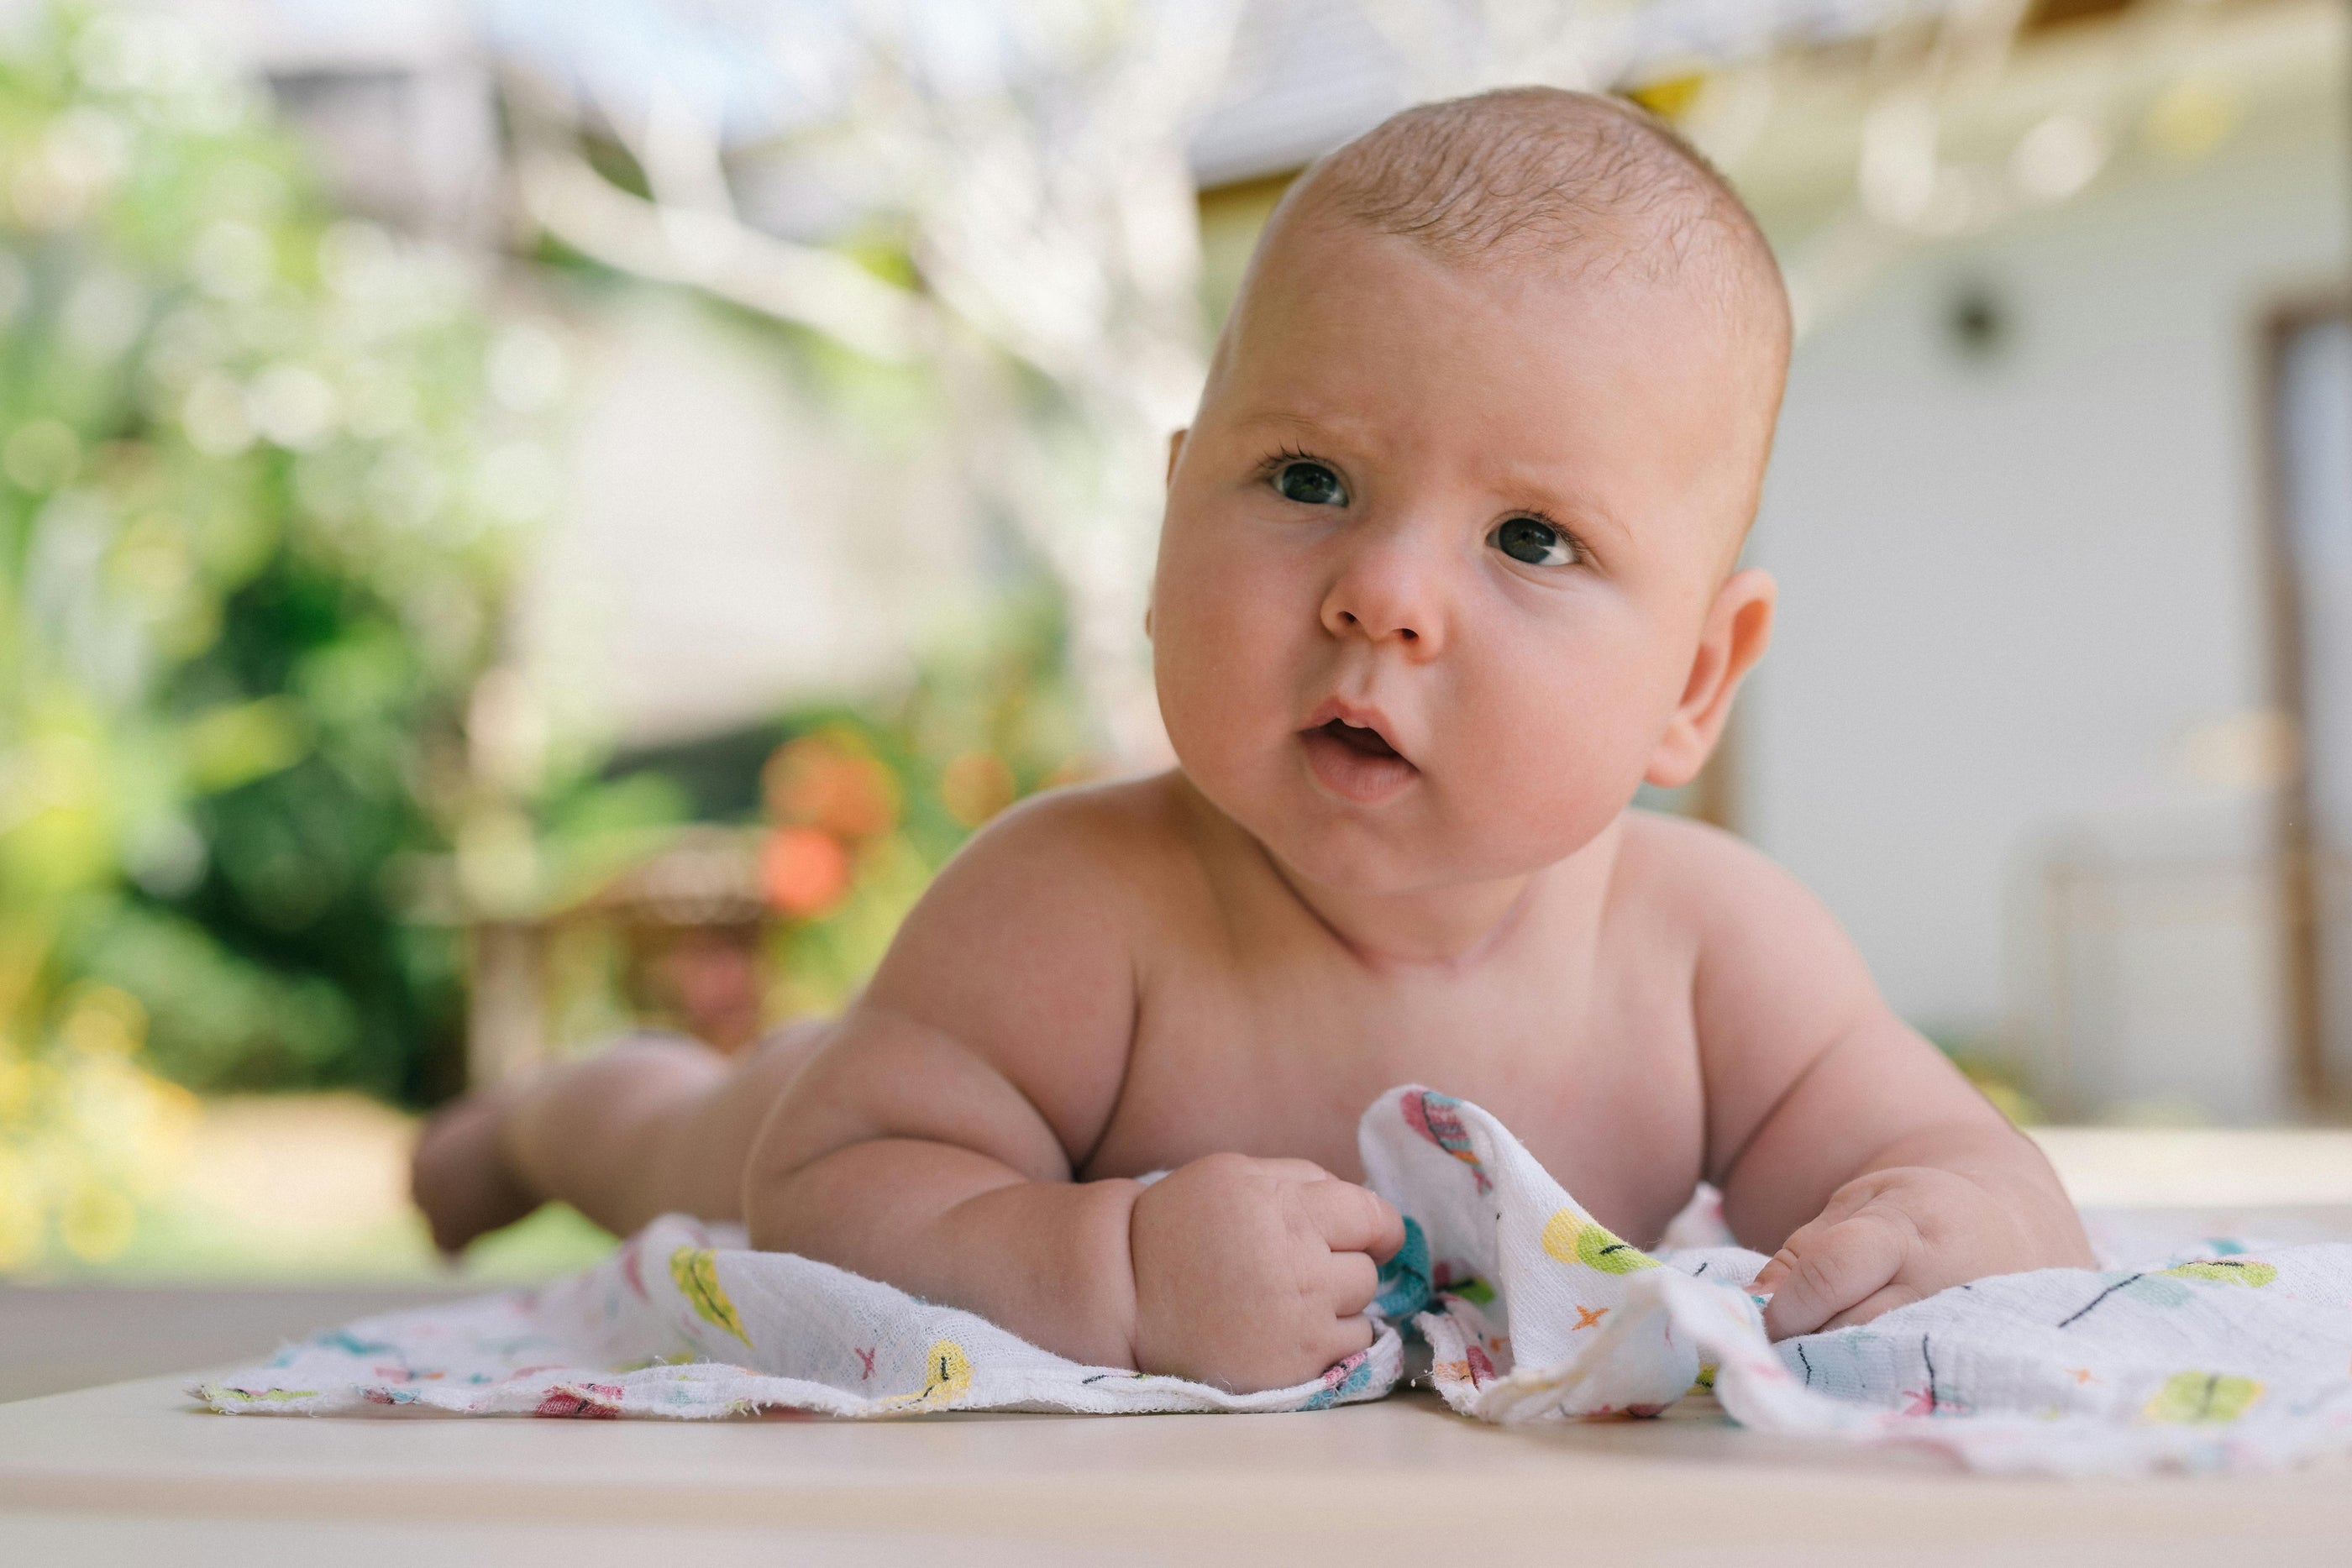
[0,0,2352,1282]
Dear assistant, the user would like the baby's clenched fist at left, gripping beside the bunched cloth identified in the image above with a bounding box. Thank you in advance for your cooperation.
[1129,1154,1404,1394]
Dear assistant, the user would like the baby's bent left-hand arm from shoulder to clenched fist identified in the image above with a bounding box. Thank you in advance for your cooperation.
[743,794,1404,1389]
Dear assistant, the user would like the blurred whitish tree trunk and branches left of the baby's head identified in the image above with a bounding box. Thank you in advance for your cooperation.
[489,0,1240,764]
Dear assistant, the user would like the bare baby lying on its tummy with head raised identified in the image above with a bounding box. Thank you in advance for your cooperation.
[417,89,2091,1389]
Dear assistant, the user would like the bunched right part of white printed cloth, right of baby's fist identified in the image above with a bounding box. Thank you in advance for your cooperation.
[1359,1088,2352,1474]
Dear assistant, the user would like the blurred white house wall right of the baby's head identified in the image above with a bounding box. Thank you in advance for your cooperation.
[1740,111,2352,1117]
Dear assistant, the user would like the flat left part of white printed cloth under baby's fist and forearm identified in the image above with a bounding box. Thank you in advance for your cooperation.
[193,1215,1402,1418]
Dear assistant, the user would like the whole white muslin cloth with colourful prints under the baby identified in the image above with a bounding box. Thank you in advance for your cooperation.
[191,1086,2352,1474]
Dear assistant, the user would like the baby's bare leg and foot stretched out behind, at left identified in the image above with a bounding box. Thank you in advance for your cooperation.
[412,1023,830,1251]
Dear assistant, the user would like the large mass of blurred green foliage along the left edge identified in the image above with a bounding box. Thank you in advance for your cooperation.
[0,9,538,1253]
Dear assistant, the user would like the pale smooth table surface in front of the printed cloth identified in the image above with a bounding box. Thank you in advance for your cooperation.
[0,1377,2352,1568]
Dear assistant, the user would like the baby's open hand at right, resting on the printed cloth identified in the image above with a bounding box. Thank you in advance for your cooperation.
[1755,1166,2091,1340]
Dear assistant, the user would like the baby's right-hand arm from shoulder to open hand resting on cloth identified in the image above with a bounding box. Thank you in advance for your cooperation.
[1693,839,2093,1338]
